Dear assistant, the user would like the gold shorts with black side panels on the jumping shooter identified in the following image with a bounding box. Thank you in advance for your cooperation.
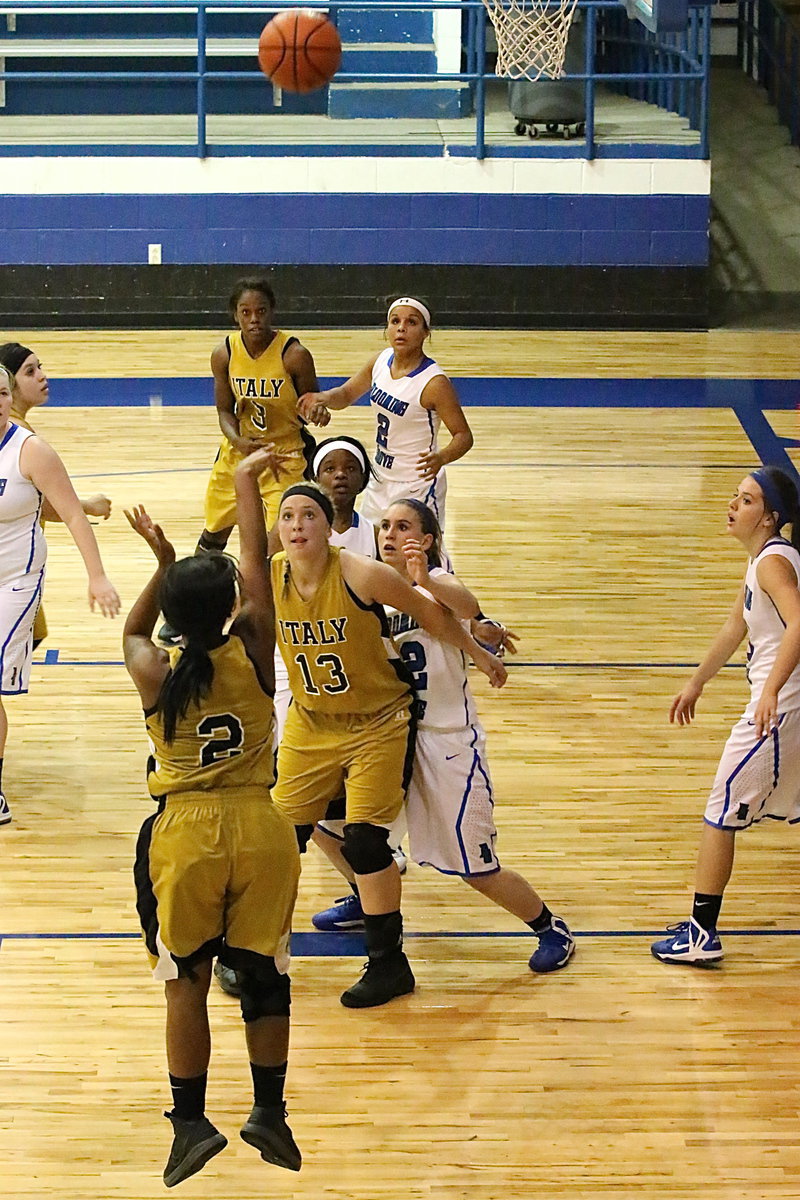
[134,787,300,979]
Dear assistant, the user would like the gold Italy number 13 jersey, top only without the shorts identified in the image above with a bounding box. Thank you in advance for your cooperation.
[271,546,411,716]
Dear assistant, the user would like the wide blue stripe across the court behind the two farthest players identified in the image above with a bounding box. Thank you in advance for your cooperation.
[34,376,798,413]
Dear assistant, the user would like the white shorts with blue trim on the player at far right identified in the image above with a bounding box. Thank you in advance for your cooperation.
[704,708,800,829]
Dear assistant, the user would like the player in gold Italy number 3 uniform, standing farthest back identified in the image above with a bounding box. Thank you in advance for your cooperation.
[158,278,330,646]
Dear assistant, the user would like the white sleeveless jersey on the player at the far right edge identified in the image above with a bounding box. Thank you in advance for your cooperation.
[742,539,800,713]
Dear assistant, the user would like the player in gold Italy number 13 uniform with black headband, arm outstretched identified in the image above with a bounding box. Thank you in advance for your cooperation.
[271,484,506,1008]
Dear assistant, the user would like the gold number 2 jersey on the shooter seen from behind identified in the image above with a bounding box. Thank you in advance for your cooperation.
[145,634,275,796]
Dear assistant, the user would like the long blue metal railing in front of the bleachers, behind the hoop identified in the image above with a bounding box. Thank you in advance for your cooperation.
[0,0,710,160]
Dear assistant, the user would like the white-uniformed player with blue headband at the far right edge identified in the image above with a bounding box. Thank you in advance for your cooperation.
[651,467,800,966]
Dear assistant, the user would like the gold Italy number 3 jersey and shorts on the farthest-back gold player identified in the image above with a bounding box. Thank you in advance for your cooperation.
[205,330,312,533]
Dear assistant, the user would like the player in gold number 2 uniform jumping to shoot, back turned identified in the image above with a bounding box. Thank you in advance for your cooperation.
[125,450,301,1187]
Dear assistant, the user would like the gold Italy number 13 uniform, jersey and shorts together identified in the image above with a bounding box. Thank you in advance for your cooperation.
[271,546,415,826]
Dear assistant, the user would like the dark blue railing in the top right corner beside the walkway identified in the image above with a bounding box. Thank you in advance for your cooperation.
[736,0,800,146]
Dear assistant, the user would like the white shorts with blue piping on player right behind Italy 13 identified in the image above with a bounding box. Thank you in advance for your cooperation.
[405,725,500,875]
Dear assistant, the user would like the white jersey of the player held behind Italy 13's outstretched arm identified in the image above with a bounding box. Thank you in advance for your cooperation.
[386,566,477,732]
